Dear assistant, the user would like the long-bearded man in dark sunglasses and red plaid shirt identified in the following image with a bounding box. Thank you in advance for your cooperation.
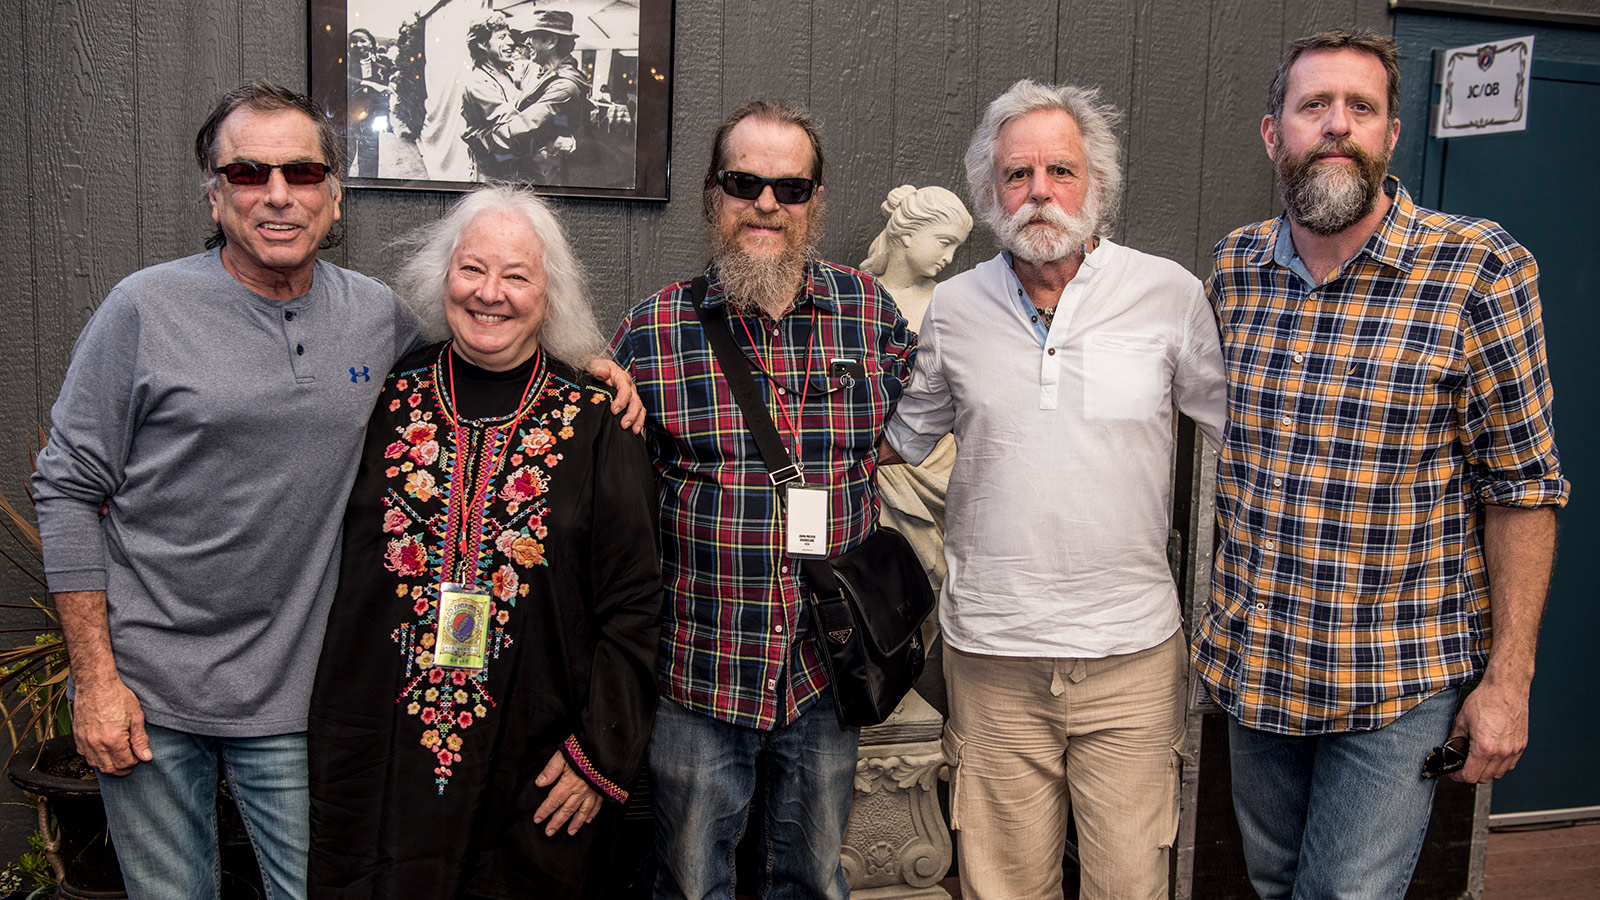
[611,101,917,900]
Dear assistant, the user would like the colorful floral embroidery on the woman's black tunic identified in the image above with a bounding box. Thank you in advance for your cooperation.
[382,358,611,796]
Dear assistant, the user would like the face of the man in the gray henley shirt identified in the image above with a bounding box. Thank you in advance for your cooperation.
[206,107,339,299]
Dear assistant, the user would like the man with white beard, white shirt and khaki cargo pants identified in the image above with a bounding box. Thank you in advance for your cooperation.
[888,80,1224,900]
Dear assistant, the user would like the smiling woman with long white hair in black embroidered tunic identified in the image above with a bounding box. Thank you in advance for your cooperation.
[309,187,661,900]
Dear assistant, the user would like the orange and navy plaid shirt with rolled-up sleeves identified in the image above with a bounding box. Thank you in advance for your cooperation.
[1194,178,1568,735]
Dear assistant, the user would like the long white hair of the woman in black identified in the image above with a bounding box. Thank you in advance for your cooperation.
[395,184,605,370]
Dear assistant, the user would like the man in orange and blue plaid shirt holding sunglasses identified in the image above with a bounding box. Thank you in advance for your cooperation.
[1194,32,1568,900]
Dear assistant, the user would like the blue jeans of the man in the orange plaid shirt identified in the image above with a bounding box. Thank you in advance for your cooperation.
[1227,687,1458,900]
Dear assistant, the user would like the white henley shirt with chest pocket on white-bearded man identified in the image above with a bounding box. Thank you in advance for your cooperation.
[888,240,1226,658]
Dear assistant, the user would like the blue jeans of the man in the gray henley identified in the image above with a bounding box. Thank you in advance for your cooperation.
[99,724,310,900]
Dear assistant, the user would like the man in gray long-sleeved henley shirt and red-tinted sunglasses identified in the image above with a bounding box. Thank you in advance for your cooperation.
[34,83,406,898]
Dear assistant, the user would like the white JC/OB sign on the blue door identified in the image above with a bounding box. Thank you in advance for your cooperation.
[1432,35,1533,138]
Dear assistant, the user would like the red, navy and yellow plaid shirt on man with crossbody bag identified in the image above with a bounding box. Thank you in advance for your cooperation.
[611,259,917,730]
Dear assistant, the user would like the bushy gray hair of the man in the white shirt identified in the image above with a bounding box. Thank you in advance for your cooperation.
[966,78,1122,234]
